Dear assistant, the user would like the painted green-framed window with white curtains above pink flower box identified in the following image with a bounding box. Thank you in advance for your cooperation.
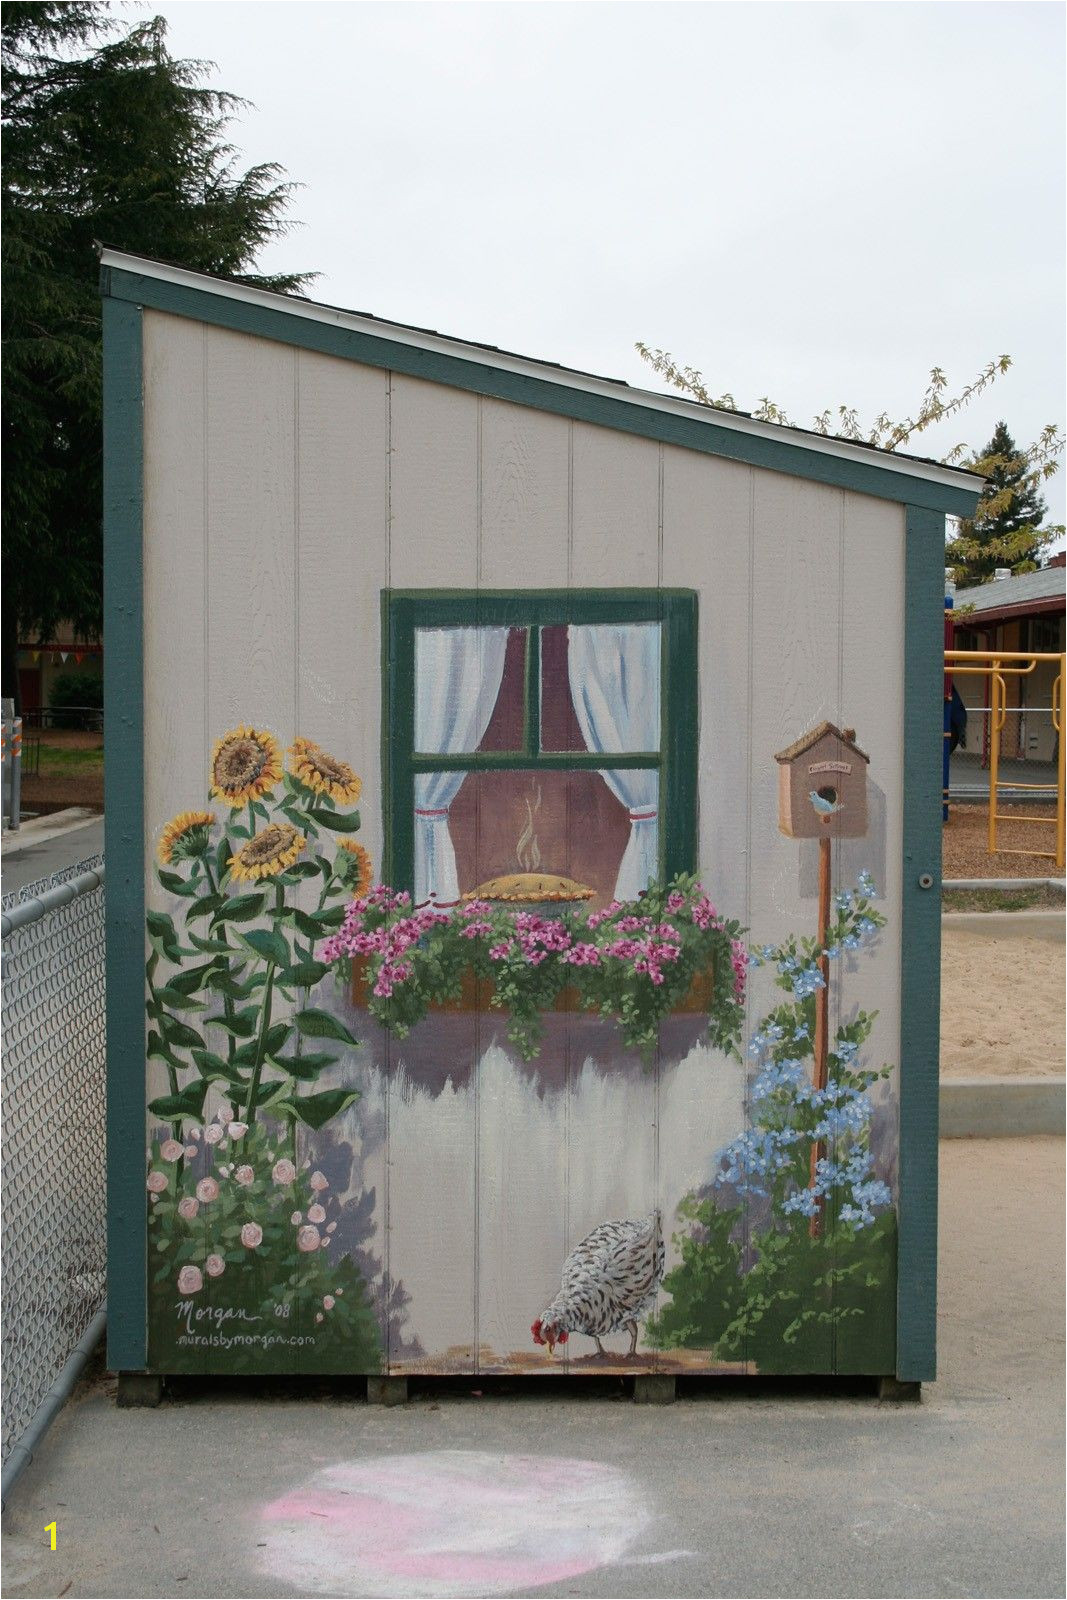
[382,590,697,906]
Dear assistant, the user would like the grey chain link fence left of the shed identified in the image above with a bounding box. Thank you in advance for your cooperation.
[0,856,107,1462]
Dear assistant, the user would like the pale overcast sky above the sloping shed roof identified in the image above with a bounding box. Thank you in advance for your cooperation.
[147,0,1065,522]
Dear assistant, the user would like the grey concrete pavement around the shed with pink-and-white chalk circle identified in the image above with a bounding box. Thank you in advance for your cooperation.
[3,1138,1064,1597]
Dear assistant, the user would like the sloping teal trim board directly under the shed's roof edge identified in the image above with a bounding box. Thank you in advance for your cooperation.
[101,267,979,517]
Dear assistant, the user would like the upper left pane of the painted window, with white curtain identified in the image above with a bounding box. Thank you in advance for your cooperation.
[414,627,525,755]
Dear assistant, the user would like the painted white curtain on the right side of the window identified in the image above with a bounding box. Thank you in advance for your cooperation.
[568,622,661,899]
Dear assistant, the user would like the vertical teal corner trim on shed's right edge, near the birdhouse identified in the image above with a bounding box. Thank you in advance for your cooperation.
[896,507,945,1382]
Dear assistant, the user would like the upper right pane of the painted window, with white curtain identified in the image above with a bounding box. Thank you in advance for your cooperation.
[541,622,661,754]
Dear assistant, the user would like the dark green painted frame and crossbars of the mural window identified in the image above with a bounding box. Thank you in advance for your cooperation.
[382,589,697,890]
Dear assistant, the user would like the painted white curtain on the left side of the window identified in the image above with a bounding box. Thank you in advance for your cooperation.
[414,627,507,906]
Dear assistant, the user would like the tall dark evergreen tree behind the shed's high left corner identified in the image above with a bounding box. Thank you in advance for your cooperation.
[0,0,313,694]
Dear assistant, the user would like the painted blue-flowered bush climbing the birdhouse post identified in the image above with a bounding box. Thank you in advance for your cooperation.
[648,874,896,1371]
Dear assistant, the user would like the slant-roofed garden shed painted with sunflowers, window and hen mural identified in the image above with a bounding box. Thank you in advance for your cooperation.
[102,250,979,1381]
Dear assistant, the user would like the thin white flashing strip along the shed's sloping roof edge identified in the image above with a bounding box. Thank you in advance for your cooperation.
[101,246,984,491]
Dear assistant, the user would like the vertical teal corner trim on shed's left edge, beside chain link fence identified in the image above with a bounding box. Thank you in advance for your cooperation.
[104,299,147,1371]
